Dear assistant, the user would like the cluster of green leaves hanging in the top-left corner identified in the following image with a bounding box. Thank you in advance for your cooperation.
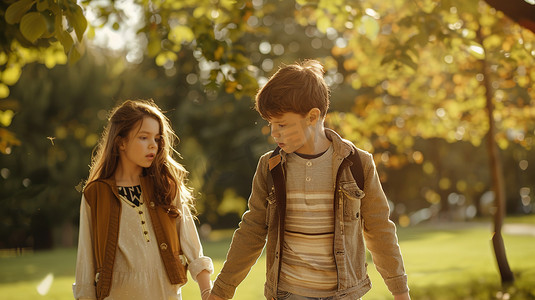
[0,0,87,86]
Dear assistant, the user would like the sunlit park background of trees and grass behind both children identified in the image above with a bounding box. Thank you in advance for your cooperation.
[0,0,535,300]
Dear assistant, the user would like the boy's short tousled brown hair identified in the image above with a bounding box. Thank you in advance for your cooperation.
[255,60,329,120]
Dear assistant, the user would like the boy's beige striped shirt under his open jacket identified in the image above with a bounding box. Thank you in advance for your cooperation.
[279,146,337,297]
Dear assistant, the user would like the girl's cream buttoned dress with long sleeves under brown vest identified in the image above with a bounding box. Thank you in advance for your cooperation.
[73,195,213,300]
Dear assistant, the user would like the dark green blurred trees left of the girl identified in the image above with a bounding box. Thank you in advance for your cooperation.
[0,54,109,249]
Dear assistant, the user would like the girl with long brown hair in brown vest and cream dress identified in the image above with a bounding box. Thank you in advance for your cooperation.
[73,100,213,300]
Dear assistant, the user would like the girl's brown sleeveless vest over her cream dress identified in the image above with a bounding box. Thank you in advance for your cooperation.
[84,176,187,299]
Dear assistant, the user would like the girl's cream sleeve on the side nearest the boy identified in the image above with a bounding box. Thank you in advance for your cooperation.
[179,205,214,281]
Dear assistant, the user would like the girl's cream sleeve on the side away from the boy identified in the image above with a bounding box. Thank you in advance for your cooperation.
[72,195,97,299]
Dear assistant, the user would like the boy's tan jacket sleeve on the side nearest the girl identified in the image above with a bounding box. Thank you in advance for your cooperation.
[212,153,269,299]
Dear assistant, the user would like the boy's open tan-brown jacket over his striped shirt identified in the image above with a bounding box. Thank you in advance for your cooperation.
[212,129,409,300]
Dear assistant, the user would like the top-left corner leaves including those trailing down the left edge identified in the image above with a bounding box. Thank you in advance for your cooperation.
[0,0,87,154]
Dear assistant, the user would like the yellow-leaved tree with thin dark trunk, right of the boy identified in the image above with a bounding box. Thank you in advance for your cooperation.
[298,0,535,283]
